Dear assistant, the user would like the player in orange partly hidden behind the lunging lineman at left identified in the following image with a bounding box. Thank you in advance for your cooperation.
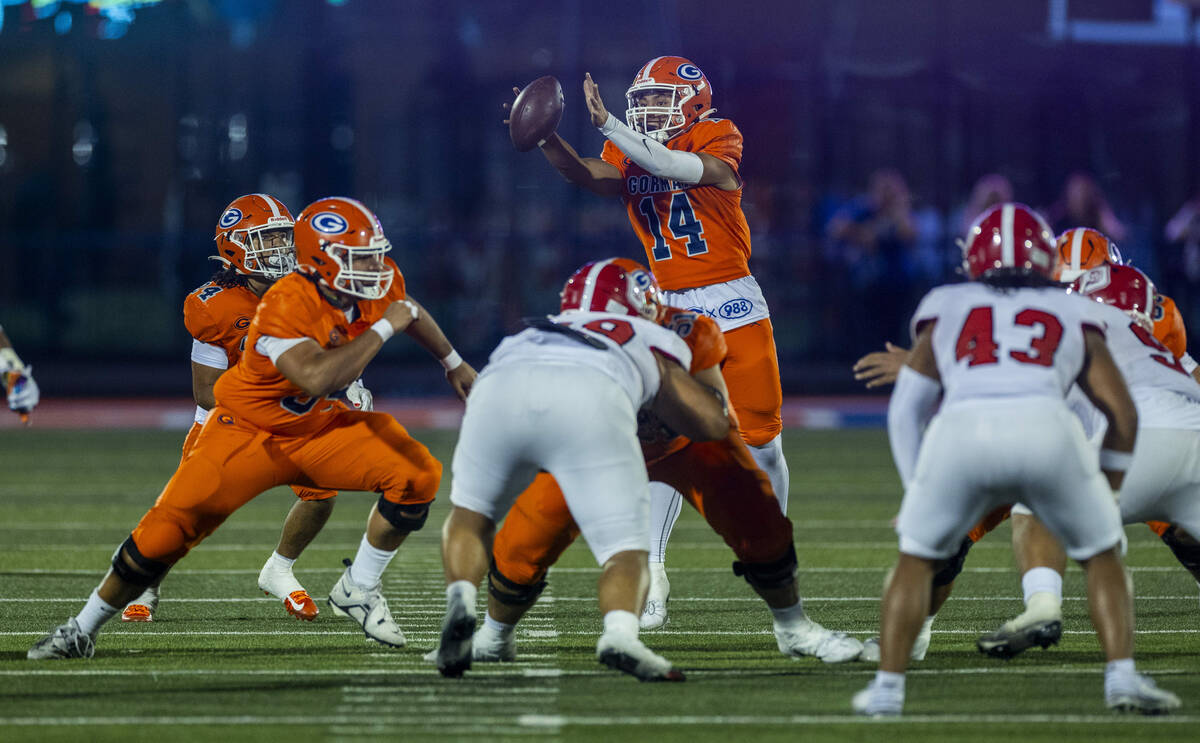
[121,193,350,622]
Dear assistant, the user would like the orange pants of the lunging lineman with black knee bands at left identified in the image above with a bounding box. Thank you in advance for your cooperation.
[133,406,442,564]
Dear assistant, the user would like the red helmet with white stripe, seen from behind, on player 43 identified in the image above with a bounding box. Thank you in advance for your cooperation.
[962,202,1058,280]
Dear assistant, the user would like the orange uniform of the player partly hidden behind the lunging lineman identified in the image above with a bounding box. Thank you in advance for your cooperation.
[180,281,337,501]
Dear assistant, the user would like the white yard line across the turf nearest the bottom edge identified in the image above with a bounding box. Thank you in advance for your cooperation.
[0,712,1200,732]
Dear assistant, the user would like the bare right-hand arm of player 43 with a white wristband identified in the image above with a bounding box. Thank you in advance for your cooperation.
[1079,328,1138,491]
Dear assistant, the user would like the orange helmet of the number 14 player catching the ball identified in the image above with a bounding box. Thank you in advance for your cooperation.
[625,56,716,142]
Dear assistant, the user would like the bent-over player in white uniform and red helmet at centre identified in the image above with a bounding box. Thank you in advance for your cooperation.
[436,259,731,681]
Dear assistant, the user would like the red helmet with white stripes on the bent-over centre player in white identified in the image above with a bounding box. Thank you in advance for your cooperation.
[562,258,662,323]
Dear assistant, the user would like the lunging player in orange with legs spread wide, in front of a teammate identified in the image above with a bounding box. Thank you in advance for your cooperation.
[26,197,475,659]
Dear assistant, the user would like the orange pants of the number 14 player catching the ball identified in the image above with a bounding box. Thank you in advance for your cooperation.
[720,318,784,446]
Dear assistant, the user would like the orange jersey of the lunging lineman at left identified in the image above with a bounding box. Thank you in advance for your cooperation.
[214,260,404,436]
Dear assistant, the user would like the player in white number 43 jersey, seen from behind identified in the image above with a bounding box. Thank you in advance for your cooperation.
[852,203,1180,715]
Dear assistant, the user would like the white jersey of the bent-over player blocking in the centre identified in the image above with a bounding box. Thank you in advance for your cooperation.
[480,311,691,409]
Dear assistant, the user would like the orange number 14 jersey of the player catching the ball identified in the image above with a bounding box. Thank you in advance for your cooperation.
[600,119,750,290]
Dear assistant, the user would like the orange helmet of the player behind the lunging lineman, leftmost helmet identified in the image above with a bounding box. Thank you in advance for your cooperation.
[214,193,295,281]
